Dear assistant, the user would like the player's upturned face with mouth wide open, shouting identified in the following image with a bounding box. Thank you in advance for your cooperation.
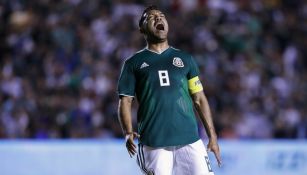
[143,10,168,41]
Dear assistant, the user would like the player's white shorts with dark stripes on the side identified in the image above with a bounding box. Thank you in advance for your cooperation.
[137,140,214,175]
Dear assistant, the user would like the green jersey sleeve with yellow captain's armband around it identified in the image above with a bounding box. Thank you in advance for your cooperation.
[187,57,203,94]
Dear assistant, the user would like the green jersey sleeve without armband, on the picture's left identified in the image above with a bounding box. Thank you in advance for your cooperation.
[117,60,135,97]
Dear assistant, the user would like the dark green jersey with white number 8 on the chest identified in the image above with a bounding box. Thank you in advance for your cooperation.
[118,47,200,147]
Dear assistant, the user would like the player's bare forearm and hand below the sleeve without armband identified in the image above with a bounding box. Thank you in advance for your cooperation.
[118,96,139,157]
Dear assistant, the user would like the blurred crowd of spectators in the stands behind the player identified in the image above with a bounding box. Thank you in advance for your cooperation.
[0,0,307,139]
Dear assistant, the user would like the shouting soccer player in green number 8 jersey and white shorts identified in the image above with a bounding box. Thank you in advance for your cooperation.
[118,6,221,175]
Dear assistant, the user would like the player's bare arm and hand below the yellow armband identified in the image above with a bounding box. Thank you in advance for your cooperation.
[192,91,222,166]
